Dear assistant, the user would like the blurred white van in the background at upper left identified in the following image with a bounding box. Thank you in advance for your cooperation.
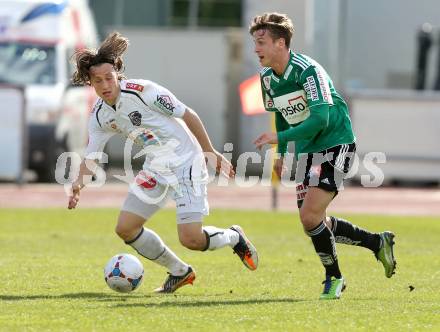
[0,0,98,181]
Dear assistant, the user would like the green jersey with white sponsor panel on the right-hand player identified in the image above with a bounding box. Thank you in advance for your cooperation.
[260,51,355,158]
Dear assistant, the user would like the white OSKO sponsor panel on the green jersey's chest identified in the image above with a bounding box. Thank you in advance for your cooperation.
[274,90,310,124]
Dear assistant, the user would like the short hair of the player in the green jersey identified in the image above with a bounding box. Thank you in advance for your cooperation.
[249,13,295,48]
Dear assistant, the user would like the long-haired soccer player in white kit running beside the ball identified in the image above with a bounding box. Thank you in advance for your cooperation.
[68,33,258,293]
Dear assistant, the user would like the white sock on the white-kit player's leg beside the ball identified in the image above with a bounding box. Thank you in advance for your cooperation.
[125,228,189,276]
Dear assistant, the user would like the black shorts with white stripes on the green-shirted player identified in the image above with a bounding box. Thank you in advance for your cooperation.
[295,143,356,208]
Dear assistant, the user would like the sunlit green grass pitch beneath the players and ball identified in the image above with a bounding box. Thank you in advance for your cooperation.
[0,209,440,332]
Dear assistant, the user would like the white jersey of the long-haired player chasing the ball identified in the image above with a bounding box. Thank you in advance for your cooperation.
[86,80,204,183]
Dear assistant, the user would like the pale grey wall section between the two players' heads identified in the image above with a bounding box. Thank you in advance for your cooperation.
[111,28,228,151]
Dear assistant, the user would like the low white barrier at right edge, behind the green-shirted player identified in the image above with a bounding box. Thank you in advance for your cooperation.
[350,90,440,182]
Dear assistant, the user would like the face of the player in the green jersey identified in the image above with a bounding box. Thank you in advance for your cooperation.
[252,29,286,67]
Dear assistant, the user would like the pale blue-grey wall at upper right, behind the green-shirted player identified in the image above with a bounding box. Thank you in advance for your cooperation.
[312,0,440,89]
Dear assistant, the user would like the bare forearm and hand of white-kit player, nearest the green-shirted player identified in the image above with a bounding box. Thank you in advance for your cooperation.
[183,108,235,177]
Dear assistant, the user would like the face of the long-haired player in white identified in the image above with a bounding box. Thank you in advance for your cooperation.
[89,63,120,105]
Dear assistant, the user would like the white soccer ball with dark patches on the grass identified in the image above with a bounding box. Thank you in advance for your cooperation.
[104,254,144,293]
